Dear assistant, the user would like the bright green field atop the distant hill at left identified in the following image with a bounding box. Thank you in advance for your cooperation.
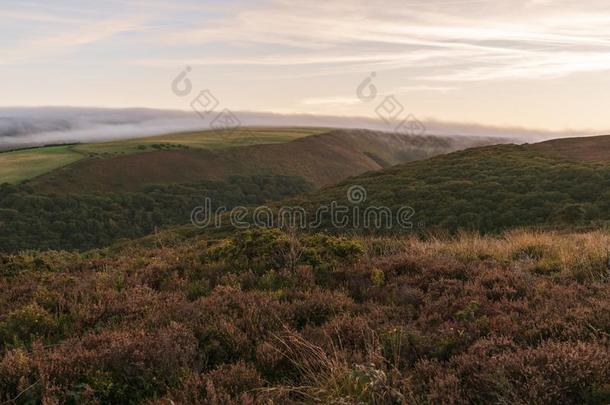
[0,128,326,184]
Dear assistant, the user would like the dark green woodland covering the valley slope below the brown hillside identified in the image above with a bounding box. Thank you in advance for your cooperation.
[0,176,310,252]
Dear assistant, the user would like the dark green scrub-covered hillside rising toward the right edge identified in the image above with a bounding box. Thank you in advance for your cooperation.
[286,137,610,232]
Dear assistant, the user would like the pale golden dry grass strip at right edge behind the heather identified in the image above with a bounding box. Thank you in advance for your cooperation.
[361,230,610,281]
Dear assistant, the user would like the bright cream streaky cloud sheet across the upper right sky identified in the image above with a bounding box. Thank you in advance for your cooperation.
[153,0,610,82]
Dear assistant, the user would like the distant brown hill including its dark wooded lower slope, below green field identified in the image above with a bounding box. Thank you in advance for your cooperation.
[0,129,504,251]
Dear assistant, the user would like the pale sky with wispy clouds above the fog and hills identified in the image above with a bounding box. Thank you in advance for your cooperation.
[0,0,610,133]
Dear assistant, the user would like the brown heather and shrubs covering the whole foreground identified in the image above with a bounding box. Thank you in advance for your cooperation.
[0,230,610,404]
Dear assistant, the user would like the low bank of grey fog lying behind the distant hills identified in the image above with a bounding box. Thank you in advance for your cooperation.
[0,107,594,150]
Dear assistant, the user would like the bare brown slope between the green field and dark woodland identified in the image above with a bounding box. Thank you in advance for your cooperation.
[30,130,503,192]
